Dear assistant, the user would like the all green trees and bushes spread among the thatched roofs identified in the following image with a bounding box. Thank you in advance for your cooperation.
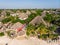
[0,9,60,39]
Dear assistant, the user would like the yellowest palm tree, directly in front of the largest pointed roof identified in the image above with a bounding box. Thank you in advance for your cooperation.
[36,24,51,39]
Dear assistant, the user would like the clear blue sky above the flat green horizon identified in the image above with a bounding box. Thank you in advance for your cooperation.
[0,0,60,9]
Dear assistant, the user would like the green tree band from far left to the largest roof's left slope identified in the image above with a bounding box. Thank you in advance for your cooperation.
[2,10,37,24]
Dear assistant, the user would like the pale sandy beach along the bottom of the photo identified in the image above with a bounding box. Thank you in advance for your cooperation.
[0,36,57,45]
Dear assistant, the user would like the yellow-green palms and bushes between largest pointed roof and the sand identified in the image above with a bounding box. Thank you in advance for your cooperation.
[26,23,58,39]
